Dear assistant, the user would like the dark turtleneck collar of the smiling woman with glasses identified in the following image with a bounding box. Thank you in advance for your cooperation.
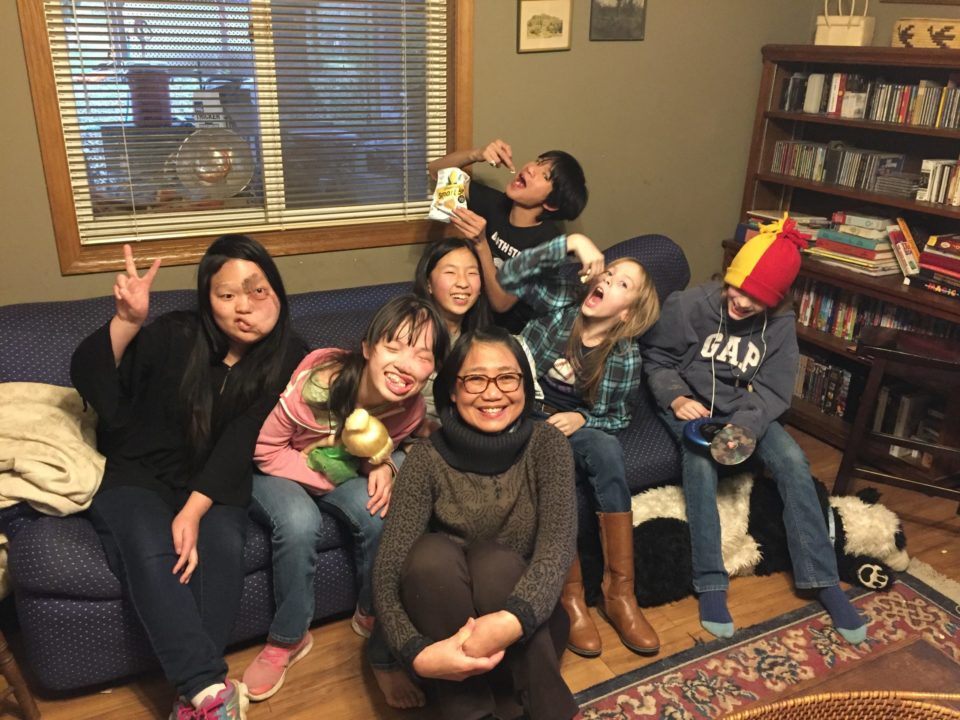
[430,407,533,475]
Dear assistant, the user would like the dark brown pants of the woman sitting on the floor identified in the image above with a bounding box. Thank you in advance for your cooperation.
[400,534,577,720]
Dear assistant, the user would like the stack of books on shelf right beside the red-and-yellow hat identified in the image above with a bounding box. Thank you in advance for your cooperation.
[804,212,900,277]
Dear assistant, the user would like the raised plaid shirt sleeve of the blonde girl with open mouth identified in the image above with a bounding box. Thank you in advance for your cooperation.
[497,235,581,310]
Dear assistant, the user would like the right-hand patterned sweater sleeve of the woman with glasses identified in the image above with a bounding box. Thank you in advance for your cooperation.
[504,423,577,640]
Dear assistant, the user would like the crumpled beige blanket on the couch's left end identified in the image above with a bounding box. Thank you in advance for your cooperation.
[0,383,104,597]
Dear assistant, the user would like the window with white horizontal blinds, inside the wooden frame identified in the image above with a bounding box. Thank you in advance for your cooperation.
[33,0,451,245]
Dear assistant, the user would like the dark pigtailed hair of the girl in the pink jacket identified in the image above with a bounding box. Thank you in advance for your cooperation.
[307,293,450,428]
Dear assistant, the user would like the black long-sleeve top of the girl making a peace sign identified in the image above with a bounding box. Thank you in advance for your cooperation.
[70,312,304,507]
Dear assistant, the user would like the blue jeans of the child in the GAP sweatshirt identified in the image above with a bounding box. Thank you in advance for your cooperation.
[661,410,840,593]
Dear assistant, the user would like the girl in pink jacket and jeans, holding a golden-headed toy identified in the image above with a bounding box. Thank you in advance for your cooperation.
[243,295,448,701]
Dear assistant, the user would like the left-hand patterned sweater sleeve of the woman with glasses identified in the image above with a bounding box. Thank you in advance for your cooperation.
[373,443,437,670]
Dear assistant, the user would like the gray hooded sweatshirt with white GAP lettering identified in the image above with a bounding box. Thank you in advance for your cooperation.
[642,282,799,438]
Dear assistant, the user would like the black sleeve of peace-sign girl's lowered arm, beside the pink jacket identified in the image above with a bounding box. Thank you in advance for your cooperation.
[189,339,304,506]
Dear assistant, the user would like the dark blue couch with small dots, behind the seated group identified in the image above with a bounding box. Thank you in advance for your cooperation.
[0,235,690,691]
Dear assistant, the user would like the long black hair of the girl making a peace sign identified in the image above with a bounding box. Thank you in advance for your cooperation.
[180,235,292,469]
